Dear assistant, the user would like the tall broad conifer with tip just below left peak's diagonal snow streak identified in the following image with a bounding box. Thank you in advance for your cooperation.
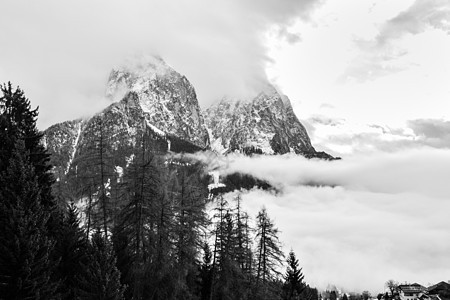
[114,134,163,299]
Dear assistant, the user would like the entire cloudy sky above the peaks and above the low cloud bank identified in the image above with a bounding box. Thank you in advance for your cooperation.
[0,0,450,129]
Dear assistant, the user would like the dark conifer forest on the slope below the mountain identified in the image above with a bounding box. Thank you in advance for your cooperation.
[0,84,318,300]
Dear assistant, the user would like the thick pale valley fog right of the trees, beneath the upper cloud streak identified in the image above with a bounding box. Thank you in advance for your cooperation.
[239,187,450,294]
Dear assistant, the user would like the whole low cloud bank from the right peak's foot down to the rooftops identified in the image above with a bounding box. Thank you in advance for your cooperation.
[188,147,450,293]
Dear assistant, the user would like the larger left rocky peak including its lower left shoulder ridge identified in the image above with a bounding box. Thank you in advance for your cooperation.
[44,58,209,179]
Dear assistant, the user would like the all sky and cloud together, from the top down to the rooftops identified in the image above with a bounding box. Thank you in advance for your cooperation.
[0,0,450,296]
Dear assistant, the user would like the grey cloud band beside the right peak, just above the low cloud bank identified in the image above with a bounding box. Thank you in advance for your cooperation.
[304,114,450,157]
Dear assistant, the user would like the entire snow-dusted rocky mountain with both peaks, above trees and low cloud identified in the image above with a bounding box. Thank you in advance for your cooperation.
[44,57,333,180]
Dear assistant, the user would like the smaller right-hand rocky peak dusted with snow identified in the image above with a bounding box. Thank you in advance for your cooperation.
[205,85,324,157]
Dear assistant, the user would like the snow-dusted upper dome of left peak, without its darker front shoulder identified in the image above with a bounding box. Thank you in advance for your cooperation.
[106,57,209,148]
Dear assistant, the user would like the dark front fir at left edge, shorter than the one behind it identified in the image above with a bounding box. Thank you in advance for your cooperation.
[0,140,58,299]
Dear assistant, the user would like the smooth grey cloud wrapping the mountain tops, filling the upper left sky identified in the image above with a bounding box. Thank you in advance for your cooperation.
[0,0,321,127]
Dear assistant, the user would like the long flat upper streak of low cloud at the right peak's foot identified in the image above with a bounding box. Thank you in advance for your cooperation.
[213,148,450,197]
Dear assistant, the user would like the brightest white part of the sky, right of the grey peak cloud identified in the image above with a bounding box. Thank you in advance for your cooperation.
[268,0,450,127]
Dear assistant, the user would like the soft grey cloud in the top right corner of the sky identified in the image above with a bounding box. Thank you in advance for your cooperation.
[340,0,450,81]
